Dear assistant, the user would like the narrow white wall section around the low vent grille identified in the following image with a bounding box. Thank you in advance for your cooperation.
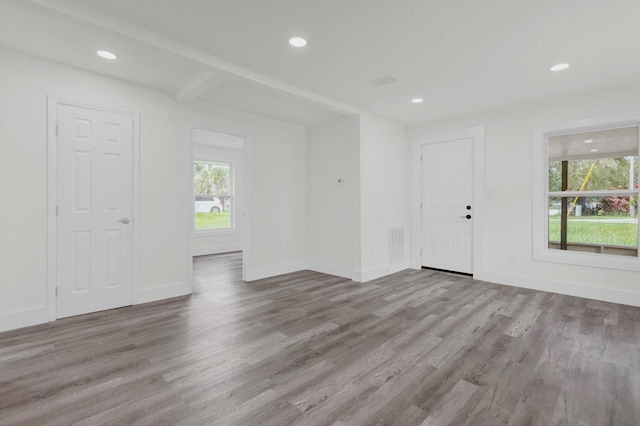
[356,114,411,281]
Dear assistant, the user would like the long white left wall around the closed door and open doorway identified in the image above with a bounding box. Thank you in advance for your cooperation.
[0,50,307,330]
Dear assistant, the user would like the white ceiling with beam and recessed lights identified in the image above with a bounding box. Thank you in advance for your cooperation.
[0,0,640,124]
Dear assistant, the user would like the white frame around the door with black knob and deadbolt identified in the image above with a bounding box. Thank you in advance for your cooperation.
[411,126,484,280]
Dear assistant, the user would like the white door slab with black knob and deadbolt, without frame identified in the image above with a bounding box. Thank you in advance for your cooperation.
[421,139,473,274]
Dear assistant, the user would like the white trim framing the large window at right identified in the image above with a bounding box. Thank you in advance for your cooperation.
[531,112,640,272]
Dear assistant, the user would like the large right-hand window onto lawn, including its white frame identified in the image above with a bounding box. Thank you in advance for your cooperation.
[534,117,640,270]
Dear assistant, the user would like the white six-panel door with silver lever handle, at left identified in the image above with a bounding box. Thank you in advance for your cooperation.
[56,104,133,318]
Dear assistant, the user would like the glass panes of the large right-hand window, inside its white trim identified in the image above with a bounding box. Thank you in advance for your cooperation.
[547,127,638,257]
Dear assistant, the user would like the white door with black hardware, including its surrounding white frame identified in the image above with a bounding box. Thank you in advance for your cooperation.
[412,128,484,278]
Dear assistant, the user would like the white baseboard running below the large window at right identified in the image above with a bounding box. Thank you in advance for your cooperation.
[483,271,640,306]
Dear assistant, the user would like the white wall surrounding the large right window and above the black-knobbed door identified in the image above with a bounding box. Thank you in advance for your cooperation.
[409,80,640,305]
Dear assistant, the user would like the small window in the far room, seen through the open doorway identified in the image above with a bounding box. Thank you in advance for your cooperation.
[198,161,233,230]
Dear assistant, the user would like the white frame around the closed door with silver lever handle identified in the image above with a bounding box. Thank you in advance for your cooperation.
[47,96,140,321]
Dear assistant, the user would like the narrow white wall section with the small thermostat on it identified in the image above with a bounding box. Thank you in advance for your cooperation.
[307,117,360,278]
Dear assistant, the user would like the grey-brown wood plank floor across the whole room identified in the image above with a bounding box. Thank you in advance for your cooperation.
[0,255,640,426]
